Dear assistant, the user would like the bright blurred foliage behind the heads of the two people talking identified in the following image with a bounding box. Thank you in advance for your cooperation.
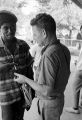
[0,0,82,39]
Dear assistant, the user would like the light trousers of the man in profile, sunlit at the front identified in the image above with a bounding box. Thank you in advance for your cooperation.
[27,96,64,120]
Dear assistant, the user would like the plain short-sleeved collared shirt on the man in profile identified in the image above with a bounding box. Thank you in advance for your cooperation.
[36,41,70,99]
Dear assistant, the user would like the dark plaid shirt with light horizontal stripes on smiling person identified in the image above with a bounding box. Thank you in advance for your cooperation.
[0,38,32,105]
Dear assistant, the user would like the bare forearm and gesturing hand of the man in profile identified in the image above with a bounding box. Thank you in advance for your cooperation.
[14,73,57,96]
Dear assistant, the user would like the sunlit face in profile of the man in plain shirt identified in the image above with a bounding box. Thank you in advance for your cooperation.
[32,26,46,46]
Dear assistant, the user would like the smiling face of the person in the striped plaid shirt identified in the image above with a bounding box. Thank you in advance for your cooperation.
[0,23,16,41]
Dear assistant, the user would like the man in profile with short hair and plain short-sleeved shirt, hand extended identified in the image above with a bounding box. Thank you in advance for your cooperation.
[15,13,70,120]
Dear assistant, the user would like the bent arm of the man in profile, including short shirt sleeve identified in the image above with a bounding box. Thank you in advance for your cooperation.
[15,53,58,96]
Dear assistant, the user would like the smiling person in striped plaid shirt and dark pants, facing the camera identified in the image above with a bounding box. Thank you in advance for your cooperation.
[0,10,32,120]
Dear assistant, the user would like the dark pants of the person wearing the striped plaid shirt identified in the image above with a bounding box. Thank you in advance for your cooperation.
[1,100,24,120]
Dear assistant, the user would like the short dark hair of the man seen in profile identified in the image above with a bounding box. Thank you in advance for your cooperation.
[30,13,56,34]
